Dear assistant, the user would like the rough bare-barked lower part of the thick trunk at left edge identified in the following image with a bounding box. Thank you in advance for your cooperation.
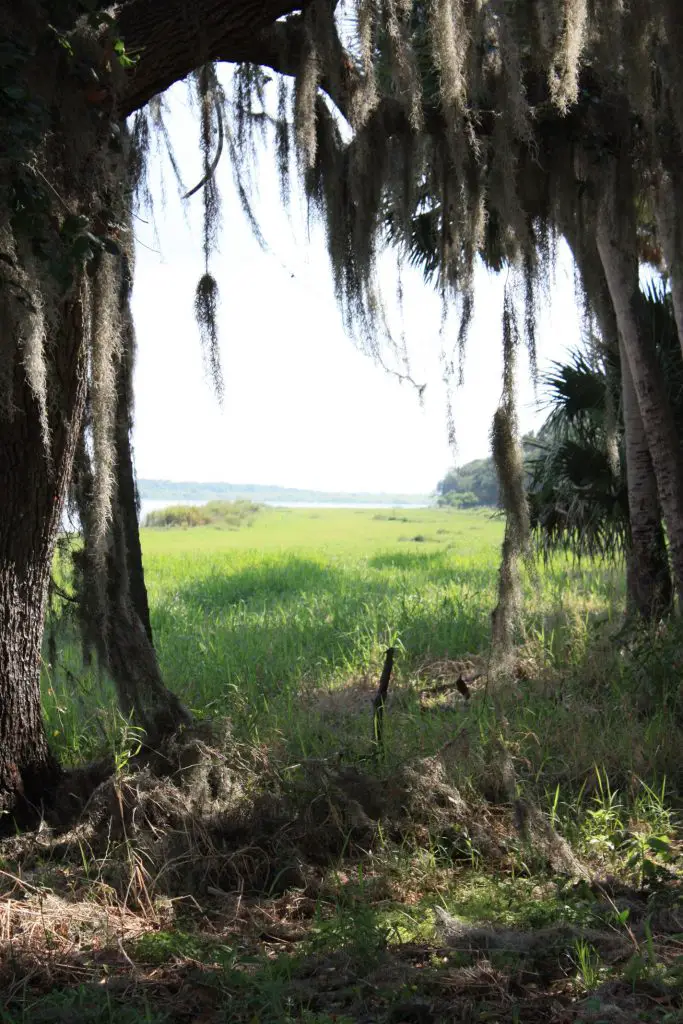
[0,303,85,821]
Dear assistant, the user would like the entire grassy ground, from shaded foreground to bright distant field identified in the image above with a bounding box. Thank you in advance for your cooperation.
[6,509,683,1024]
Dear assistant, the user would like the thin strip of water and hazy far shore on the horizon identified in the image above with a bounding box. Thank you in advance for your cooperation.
[138,480,433,508]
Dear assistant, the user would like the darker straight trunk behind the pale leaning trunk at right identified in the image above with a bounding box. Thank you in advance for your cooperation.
[620,335,673,620]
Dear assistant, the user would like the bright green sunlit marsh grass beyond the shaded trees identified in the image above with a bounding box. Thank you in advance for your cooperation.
[45,509,621,760]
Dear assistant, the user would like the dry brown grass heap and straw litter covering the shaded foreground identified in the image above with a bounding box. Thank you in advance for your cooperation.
[0,700,680,1024]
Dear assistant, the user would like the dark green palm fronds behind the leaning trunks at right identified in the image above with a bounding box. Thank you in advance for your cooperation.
[526,283,683,617]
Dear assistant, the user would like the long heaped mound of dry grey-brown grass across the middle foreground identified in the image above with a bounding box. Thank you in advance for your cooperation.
[0,712,586,918]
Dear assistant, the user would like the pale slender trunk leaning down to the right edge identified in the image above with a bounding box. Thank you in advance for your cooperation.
[596,176,683,601]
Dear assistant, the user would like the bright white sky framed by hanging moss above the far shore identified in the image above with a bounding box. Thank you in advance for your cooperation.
[133,74,581,493]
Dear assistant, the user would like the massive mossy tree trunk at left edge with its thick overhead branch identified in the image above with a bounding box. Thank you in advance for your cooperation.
[0,0,305,811]
